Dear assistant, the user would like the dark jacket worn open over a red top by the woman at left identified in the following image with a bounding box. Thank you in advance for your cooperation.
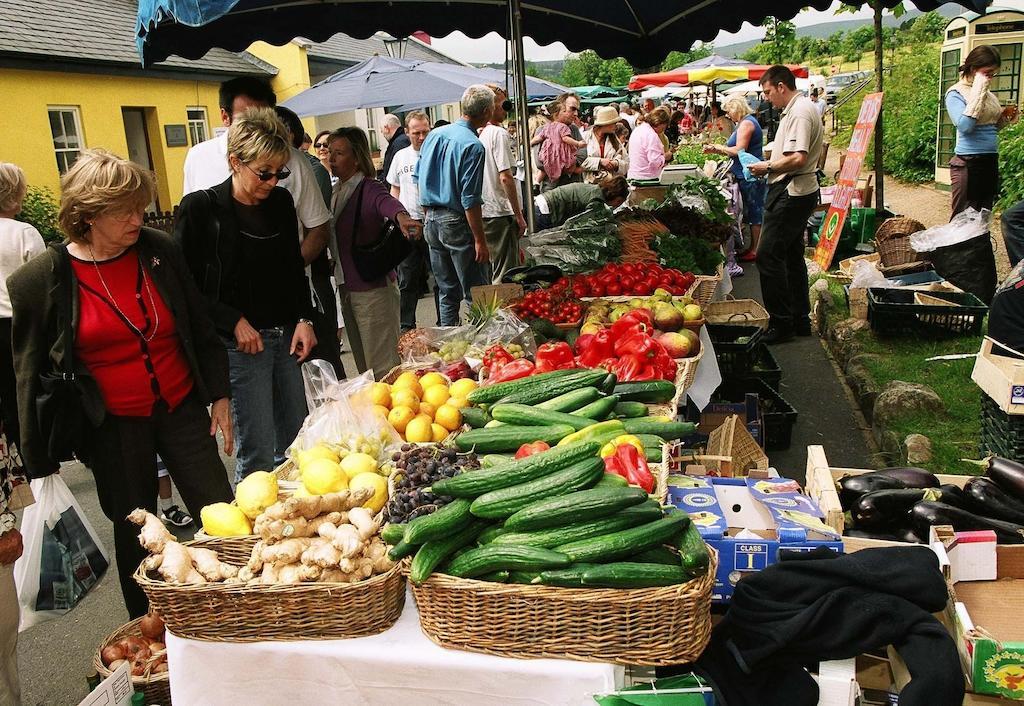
[7,227,230,477]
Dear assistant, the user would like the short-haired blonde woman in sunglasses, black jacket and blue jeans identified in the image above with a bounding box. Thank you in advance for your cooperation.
[174,108,316,482]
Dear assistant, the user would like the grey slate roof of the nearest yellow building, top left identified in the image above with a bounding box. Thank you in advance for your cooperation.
[0,0,278,76]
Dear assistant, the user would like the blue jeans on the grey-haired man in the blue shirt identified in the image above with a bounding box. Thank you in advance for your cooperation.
[423,208,490,326]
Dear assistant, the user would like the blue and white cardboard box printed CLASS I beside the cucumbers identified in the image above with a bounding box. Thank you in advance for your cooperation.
[669,475,843,604]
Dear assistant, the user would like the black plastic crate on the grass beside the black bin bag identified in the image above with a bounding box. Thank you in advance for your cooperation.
[867,288,988,338]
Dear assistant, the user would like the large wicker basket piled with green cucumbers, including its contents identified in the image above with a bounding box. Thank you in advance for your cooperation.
[382,442,717,665]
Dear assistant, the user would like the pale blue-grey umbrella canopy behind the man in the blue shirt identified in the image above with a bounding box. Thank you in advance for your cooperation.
[282,56,568,118]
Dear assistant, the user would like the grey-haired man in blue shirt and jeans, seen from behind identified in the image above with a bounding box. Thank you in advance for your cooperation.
[413,85,495,326]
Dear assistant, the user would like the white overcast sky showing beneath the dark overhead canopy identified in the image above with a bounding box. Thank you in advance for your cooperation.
[433,0,1024,64]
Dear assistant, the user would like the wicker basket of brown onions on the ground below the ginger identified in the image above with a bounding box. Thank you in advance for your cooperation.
[92,613,171,704]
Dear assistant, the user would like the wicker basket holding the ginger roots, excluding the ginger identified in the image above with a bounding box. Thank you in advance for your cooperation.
[134,537,406,642]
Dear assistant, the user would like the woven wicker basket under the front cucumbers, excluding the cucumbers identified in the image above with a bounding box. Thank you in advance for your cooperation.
[413,547,718,666]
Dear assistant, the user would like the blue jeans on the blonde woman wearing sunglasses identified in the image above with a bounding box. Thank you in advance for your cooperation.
[224,327,306,483]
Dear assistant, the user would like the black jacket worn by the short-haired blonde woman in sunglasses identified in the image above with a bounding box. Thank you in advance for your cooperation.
[174,173,312,338]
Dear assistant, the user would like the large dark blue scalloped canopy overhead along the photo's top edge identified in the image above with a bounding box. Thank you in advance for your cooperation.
[136,0,988,68]
